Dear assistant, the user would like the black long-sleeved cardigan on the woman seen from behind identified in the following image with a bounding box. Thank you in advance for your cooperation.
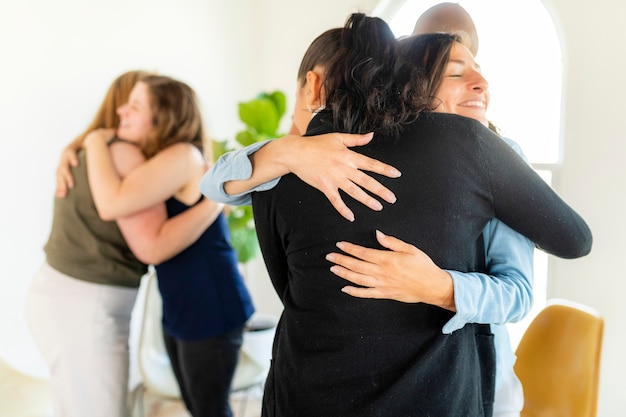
[253,113,591,417]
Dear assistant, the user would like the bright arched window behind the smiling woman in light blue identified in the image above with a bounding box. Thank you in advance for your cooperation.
[374,0,563,346]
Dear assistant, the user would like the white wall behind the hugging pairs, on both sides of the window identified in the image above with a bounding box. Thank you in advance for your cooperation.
[0,0,626,417]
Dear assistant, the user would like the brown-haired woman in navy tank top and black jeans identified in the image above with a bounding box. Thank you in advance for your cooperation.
[83,76,254,417]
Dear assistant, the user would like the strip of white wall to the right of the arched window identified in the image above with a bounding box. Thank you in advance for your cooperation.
[544,0,626,416]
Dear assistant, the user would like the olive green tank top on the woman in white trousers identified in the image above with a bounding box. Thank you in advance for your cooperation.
[44,142,147,288]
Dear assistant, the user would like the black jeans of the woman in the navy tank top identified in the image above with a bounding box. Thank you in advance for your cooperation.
[163,327,243,417]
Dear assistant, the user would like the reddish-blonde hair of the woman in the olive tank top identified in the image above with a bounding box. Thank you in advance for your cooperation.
[80,70,149,142]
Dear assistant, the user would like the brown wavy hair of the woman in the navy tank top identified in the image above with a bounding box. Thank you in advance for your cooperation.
[141,75,204,158]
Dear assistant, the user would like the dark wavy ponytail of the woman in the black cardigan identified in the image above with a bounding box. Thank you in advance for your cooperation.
[324,13,425,134]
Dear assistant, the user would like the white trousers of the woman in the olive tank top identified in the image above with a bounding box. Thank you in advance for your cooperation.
[27,264,137,417]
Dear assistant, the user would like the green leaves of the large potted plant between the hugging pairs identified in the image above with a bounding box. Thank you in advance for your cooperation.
[213,91,287,264]
